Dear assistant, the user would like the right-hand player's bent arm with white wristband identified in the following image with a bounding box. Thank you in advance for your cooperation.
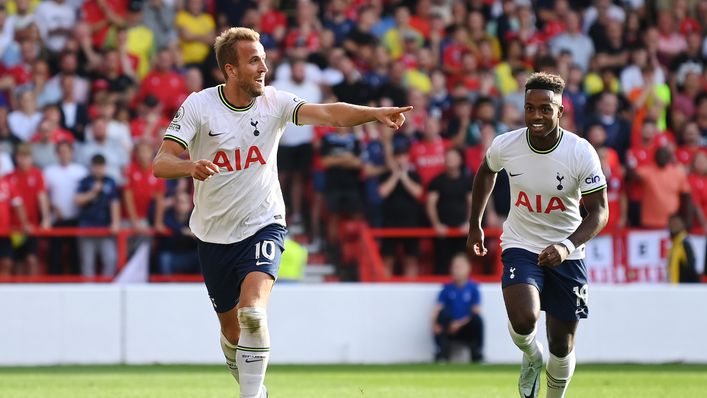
[538,188,609,267]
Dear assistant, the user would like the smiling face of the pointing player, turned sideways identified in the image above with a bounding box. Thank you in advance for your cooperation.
[226,40,268,97]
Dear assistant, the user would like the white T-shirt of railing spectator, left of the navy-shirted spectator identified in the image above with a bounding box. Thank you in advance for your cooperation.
[44,163,88,219]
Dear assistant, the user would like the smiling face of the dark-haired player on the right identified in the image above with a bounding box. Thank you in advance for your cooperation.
[525,89,564,137]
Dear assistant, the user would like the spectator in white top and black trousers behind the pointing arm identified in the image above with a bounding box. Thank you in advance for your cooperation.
[273,59,323,235]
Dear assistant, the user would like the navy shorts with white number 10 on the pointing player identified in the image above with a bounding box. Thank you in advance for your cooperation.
[197,224,287,312]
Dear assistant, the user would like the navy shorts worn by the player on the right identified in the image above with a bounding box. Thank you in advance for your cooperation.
[501,248,589,321]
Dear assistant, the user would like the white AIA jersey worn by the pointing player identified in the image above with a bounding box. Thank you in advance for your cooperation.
[164,85,304,244]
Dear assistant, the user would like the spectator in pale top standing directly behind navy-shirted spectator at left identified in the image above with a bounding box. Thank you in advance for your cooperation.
[77,117,130,186]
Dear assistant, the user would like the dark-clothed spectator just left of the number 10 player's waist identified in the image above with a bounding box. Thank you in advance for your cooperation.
[158,192,199,275]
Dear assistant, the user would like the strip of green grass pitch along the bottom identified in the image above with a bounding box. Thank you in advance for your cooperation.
[0,365,707,398]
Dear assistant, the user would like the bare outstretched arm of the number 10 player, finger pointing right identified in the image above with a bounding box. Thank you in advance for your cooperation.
[297,102,412,129]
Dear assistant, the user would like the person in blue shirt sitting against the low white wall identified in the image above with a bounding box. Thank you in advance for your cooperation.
[432,253,484,362]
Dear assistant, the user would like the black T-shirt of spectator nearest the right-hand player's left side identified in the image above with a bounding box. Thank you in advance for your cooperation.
[429,173,473,227]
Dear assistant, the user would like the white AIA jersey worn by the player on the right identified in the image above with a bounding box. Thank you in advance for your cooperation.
[486,128,606,260]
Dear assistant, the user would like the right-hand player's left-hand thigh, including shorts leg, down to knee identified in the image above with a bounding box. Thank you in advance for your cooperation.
[501,248,544,334]
